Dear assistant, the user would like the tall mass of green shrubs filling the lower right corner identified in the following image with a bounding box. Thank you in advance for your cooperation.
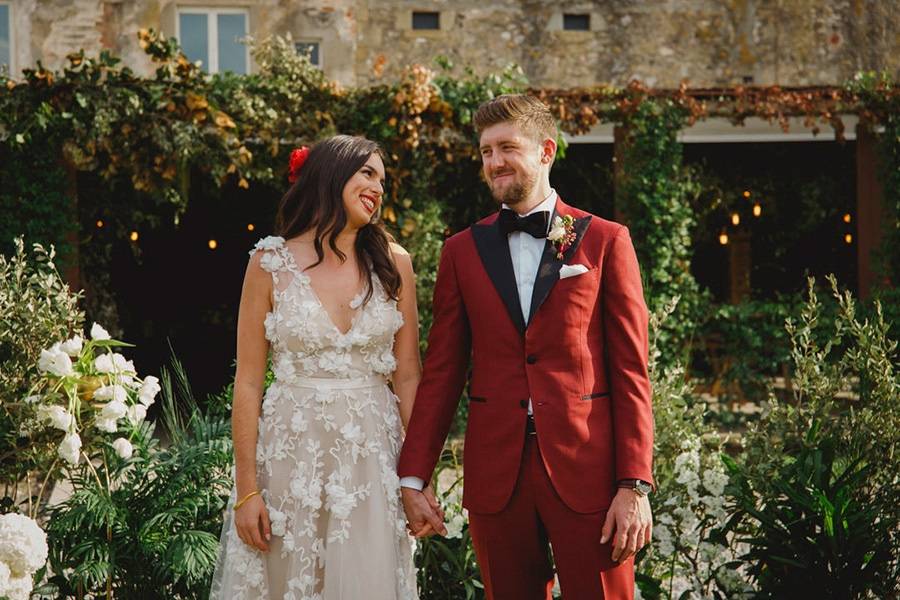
[730,278,900,598]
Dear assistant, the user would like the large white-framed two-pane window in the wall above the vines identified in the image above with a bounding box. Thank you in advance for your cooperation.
[177,8,250,74]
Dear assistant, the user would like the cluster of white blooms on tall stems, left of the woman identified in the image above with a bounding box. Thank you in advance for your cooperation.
[25,323,160,472]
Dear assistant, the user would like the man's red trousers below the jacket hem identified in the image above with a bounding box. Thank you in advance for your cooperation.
[469,435,634,600]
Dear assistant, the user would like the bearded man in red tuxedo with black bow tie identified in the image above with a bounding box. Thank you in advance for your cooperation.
[398,95,653,600]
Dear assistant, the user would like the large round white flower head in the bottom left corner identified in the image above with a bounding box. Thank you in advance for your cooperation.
[0,513,47,600]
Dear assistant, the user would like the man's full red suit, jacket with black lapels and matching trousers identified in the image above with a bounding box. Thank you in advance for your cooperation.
[398,200,653,600]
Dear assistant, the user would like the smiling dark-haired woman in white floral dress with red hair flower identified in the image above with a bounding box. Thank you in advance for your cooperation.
[210,135,439,600]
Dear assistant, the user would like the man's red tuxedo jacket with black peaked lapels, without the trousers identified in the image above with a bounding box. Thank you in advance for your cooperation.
[398,200,653,513]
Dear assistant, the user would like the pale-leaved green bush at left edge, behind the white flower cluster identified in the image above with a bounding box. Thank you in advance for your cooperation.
[0,237,84,486]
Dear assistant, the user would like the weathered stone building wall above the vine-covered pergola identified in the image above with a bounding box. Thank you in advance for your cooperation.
[0,0,900,88]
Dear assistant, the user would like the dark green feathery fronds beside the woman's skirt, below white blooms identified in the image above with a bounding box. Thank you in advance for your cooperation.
[44,360,232,598]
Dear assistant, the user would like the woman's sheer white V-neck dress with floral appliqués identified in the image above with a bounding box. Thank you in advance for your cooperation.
[210,236,418,600]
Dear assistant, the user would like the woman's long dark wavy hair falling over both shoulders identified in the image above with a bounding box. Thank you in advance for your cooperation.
[275,135,400,302]
